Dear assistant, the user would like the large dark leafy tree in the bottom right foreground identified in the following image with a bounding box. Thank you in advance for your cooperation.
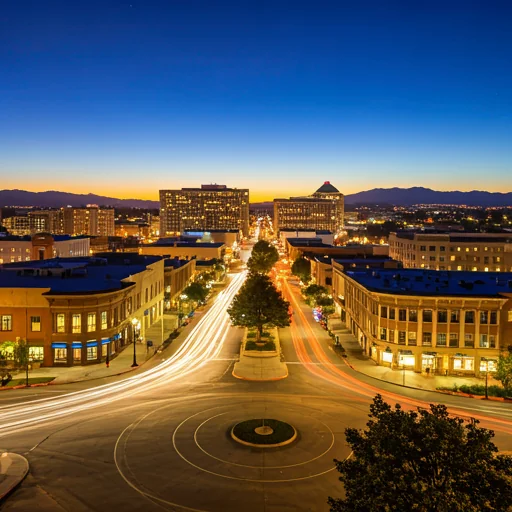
[328,395,512,512]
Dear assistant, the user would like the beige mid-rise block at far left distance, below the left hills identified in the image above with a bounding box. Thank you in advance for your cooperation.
[62,205,115,236]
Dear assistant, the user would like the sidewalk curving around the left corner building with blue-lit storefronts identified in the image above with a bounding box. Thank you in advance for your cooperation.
[6,318,174,389]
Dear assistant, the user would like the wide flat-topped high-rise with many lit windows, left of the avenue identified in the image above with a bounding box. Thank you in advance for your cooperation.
[160,185,249,237]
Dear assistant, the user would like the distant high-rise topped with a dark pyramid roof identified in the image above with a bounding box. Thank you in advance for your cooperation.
[274,181,345,234]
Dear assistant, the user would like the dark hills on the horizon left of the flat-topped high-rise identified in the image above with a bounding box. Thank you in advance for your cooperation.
[0,189,160,208]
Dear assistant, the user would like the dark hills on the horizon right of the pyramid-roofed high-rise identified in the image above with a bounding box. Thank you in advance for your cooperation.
[345,187,512,206]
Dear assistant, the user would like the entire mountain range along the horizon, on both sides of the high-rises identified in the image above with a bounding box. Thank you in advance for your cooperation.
[0,187,512,208]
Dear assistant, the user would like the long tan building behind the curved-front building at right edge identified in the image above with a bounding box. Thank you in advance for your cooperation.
[389,231,512,272]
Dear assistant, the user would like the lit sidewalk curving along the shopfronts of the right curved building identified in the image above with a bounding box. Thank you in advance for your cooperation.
[335,329,499,391]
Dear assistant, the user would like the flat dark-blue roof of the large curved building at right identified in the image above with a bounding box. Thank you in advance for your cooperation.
[345,269,512,297]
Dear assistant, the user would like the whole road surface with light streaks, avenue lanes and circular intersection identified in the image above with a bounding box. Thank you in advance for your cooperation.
[0,273,512,512]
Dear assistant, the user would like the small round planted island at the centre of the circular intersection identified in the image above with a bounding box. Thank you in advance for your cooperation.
[231,419,297,448]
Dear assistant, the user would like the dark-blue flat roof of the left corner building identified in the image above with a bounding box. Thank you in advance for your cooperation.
[0,253,161,295]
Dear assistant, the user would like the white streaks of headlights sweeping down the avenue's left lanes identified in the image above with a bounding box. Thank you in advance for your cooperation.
[0,272,246,437]
